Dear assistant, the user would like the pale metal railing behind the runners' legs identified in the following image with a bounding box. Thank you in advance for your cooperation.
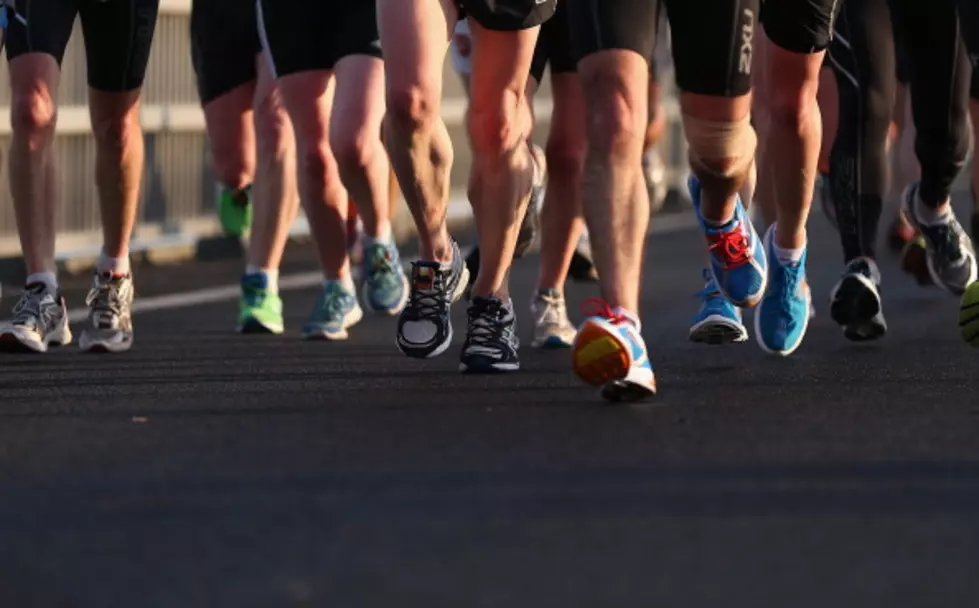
[0,0,683,257]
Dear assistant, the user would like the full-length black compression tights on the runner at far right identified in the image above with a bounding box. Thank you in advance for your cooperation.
[827,0,979,261]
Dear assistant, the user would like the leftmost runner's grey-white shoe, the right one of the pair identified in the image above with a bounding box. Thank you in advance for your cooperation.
[78,272,135,353]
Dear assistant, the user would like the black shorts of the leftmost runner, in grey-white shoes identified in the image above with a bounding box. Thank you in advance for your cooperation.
[7,0,160,92]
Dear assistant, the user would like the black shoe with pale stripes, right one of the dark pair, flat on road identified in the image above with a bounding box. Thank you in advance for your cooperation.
[459,297,520,374]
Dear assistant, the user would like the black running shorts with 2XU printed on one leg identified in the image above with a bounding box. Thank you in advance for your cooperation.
[568,0,758,97]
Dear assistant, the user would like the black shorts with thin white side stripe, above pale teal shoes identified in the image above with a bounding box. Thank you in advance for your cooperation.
[258,0,381,78]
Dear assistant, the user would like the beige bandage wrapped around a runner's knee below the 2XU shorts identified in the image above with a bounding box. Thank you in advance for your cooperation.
[683,114,758,196]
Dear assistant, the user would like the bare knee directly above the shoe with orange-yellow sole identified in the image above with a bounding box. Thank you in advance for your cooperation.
[582,73,648,156]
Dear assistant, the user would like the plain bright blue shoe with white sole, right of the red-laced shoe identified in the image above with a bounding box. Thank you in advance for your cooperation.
[755,224,812,357]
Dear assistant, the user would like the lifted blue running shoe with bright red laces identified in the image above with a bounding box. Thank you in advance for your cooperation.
[687,174,768,308]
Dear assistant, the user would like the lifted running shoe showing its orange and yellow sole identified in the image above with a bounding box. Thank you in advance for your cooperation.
[572,298,656,403]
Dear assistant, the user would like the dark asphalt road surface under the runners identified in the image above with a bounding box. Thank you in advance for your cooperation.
[0,207,979,608]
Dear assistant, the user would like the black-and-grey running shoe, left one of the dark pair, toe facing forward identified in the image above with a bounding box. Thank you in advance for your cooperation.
[398,241,469,359]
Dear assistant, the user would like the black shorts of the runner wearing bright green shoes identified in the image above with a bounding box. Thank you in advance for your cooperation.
[190,0,262,105]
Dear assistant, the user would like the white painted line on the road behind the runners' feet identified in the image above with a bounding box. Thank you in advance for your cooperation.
[59,204,697,323]
